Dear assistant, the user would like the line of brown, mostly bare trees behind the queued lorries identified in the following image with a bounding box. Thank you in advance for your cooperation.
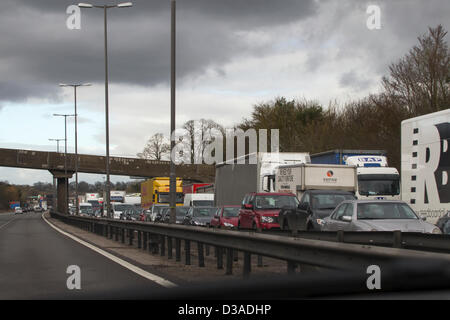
[138,25,450,169]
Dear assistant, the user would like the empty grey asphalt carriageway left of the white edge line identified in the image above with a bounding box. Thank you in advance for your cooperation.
[0,213,171,299]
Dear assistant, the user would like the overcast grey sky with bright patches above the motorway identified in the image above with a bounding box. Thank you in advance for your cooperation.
[0,0,450,184]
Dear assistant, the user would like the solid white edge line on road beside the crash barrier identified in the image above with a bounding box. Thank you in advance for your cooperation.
[42,214,177,288]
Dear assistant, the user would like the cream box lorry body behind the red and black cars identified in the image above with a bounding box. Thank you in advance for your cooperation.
[275,164,357,199]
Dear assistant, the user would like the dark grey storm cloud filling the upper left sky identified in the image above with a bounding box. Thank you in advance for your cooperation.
[0,0,316,101]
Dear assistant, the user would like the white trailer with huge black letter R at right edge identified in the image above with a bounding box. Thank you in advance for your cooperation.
[401,109,450,223]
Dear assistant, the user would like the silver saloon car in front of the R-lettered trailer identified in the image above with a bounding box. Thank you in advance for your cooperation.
[322,200,441,233]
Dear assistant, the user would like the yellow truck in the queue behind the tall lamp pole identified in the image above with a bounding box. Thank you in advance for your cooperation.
[141,177,183,209]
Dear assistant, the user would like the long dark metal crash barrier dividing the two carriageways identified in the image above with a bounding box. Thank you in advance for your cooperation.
[51,212,450,277]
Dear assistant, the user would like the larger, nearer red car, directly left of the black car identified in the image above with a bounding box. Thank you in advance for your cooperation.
[238,192,298,230]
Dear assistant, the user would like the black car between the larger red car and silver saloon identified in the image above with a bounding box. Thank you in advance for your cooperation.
[278,190,356,231]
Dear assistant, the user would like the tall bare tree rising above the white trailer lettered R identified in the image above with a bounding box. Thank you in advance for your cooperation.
[383,25,450,116]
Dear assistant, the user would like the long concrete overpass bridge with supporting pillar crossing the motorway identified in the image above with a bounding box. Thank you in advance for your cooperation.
[0,148,215,212]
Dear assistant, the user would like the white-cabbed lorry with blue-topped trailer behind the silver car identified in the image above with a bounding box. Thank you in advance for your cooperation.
[311,149,400,200]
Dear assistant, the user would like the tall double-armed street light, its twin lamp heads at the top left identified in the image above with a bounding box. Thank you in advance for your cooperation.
[78,2,133,217]
